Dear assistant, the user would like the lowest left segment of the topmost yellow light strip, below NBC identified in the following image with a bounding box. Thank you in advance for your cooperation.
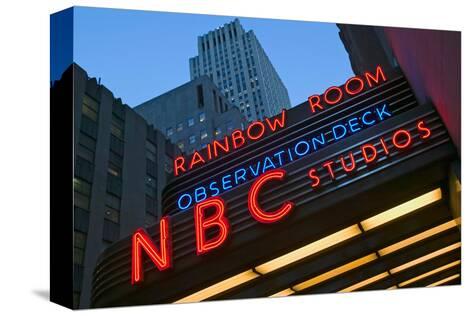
[174,270,259,303]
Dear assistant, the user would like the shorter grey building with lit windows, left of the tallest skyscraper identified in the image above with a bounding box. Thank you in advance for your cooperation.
[134,76,246,154]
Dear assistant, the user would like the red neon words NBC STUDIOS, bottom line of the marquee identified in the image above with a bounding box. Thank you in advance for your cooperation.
[131,120,432,284]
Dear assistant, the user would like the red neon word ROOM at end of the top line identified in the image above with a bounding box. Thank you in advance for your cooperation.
[308,66,386,113]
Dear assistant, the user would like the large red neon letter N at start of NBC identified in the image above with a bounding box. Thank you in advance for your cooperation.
[131,216,172,284]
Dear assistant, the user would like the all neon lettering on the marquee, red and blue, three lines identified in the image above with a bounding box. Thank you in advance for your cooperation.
[131,66,432,284]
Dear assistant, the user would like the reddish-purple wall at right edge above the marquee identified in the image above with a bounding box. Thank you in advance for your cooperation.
[384,27,461,154]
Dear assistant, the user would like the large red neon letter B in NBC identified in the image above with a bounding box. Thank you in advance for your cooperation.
[194,197,230,255]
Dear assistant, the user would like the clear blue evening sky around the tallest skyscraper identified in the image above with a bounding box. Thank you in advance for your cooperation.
[70,7,352,107]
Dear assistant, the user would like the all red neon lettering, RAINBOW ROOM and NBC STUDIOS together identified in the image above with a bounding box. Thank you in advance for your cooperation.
[131,66,432,284]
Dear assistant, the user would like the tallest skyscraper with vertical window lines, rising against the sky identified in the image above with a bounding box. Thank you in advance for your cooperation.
[189,19,291,121]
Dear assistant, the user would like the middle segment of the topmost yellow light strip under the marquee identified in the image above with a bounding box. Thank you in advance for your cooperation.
[255,224,361,274]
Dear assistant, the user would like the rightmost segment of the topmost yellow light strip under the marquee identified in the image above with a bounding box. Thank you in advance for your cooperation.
[361,188,442,231]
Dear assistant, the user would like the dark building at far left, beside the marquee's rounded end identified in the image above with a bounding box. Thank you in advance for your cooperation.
[51,64,177,308]
